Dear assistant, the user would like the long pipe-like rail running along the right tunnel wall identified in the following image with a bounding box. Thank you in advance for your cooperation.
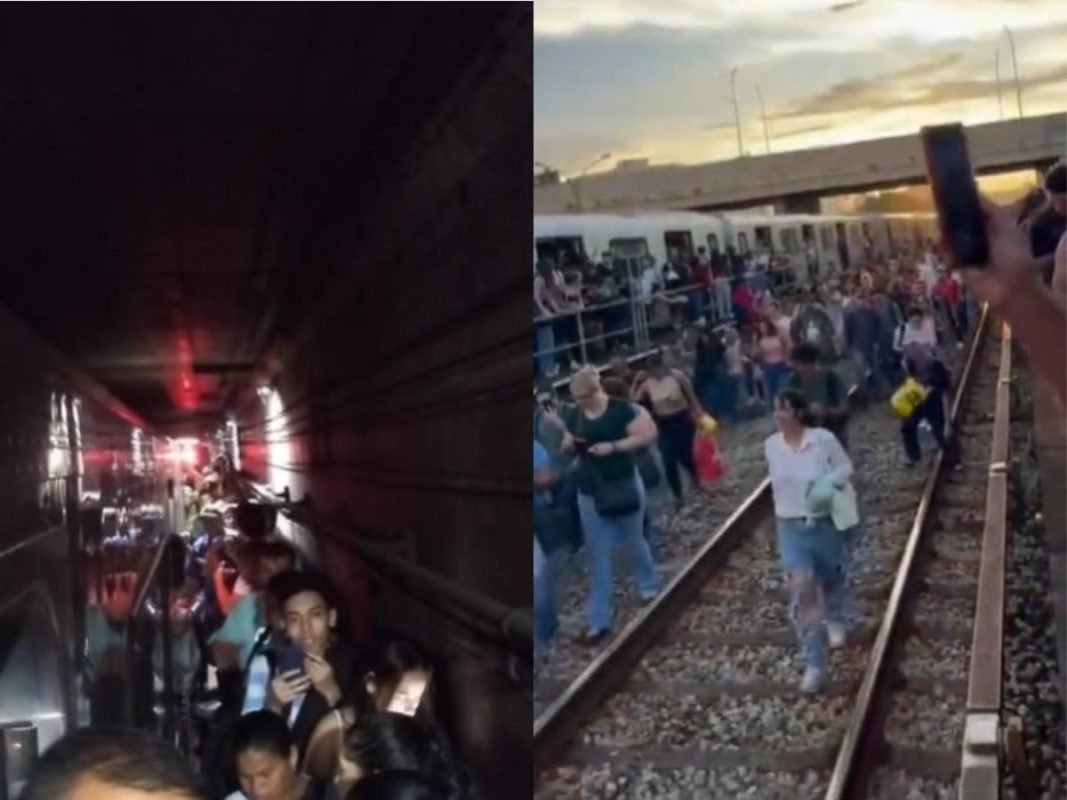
[240,478,534,651]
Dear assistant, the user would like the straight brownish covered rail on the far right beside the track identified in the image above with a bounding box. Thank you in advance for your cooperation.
[959,324,1012,800]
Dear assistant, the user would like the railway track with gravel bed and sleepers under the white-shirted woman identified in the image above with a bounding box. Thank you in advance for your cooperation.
[535,320,1028,800]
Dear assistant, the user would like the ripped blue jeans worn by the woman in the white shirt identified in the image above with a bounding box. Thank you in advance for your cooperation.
[777,517,848,670]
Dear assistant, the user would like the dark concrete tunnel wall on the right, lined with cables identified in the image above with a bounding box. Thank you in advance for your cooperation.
[239,7,532,797]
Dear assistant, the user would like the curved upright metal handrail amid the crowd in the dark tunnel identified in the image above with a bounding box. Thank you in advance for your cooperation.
[126,533,185,739]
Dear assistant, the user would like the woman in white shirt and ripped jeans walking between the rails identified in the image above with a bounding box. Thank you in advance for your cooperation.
[764,389,853,692]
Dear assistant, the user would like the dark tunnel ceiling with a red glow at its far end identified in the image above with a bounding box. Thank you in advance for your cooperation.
[0,3,511,428]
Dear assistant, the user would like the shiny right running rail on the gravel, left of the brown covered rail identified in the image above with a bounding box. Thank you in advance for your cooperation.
[824,305,990,800]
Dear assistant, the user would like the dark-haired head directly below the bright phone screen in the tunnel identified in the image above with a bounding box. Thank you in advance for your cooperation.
[341,711,442,780]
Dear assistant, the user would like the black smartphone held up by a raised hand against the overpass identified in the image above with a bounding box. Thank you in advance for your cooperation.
[920,124,989,267]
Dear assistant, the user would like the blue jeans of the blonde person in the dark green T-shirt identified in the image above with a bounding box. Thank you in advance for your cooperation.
[578,471,659,634]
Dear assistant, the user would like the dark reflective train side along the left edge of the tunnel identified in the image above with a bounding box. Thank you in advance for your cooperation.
[0,308,147,750]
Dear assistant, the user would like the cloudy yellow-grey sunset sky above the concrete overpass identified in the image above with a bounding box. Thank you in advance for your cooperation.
[534,0,1067,174]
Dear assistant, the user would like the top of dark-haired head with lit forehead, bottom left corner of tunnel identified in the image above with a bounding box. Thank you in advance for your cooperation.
[19,727,207,800]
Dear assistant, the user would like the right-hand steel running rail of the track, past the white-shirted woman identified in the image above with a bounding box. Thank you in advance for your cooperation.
[825,306,991,800]
